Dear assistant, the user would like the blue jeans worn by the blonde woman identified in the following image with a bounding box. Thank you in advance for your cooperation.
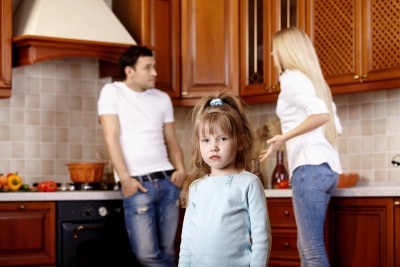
[292,163,339,267]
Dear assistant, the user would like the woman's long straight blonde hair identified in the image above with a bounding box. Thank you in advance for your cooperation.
[272,27,338,147]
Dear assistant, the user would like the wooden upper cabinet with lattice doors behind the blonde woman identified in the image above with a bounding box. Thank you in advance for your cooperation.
[307,0,400,93]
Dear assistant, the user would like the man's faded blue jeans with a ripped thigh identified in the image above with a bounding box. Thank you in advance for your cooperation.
[124,178,180,267]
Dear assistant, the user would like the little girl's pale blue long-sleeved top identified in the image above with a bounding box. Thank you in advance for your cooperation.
[179,171,271,267]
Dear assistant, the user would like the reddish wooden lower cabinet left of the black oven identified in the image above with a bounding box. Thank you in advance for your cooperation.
[0,202,56,267]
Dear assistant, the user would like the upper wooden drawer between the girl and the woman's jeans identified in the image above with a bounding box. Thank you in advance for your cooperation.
[267,198,296,228]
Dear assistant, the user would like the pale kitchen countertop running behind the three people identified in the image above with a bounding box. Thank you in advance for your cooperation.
[0,182,400,202]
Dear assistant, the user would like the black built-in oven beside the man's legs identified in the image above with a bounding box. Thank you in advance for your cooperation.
[57,200,141,267]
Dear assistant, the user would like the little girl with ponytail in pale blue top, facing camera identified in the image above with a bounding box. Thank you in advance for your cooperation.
[179,91,271,267]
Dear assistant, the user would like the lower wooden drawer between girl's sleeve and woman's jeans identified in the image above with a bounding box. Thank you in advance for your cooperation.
[270,229,300,261]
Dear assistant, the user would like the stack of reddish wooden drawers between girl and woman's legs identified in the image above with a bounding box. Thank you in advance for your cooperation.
[267,198,300,267]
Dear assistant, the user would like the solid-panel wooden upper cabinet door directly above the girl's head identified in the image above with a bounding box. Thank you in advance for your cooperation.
[181,0,239,98]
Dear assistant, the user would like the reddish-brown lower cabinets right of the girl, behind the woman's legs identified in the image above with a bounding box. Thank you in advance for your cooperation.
[267,197,400,267]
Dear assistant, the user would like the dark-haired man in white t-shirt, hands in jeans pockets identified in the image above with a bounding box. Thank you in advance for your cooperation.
[98,46,186,267]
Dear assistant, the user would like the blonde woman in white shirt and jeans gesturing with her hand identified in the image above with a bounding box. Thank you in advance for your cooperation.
[260,27,342,267]
